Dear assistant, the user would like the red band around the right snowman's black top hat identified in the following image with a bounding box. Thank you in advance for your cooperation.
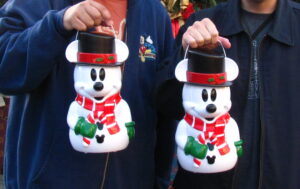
[186,72,227,85]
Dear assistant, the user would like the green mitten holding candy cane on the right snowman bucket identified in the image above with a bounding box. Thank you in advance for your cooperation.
[184,136,208,159]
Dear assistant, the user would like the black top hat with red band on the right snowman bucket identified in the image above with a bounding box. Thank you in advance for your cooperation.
[186,48,232,86]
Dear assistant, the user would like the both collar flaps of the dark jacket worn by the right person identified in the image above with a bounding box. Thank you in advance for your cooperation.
[220,0,295,46]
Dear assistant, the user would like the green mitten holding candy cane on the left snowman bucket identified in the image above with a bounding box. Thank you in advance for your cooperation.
[74,117,97,138]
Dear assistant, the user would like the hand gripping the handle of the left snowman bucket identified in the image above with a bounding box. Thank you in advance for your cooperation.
[63,0,113,31]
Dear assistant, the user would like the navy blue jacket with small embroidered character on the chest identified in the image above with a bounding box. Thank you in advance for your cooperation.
[0,0,173,189]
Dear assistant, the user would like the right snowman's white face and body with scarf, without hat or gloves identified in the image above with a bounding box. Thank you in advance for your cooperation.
[176,83,240,173]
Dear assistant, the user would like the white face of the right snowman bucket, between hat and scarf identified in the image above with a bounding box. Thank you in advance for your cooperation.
[182,83,231,122]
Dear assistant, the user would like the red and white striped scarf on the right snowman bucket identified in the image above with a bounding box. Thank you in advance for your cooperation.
[184,113,230,155]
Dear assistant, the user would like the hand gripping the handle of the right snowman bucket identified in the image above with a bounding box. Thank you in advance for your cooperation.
[182,18,231,49]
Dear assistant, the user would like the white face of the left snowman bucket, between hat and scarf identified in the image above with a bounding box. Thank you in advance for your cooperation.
[74,65,122,101]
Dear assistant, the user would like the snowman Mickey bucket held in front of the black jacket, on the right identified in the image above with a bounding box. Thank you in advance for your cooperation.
[175,45,243,173]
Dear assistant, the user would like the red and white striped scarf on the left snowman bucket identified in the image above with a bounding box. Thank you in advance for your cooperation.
[76,93,122,135]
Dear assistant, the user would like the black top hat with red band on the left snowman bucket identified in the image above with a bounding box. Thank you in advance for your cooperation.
[77,32,122,66]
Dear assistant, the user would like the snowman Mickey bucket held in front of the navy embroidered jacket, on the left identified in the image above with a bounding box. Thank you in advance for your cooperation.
[66,32,134,153]
